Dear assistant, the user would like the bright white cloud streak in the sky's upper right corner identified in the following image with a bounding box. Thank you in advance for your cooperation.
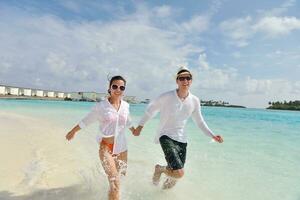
[220,0,300,47]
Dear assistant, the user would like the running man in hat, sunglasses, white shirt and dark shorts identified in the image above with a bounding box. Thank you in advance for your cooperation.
[134,68,223,189]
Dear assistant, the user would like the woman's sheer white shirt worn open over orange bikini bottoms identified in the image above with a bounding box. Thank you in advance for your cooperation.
[79,99,131,154]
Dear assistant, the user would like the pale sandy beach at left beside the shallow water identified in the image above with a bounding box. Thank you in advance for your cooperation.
[0,111,99,199]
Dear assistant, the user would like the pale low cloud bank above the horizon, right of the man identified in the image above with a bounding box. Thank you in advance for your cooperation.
[193,52,300,107]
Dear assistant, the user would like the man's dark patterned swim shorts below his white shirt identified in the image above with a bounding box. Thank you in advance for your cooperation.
[159,135,187,170]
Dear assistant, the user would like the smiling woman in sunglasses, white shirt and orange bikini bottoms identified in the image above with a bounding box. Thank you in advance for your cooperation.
[66,76,134,200]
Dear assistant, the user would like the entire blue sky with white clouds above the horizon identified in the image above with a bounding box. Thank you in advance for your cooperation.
[0,0,300,107]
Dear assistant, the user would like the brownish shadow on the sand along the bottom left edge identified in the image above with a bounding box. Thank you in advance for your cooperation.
[0,185,101,200]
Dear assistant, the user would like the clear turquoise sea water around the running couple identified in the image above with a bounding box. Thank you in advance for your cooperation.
[0,99,300,200]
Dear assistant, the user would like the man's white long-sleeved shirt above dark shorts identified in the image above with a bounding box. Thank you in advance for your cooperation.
[139,90,214,143]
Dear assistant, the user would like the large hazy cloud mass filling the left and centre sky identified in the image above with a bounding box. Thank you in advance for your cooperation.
[0,5,200,97]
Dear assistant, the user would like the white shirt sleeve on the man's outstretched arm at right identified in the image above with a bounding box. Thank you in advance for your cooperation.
[192,99,215,137]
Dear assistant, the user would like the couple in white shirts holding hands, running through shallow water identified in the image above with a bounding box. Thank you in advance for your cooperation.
[66,68,223,200]
